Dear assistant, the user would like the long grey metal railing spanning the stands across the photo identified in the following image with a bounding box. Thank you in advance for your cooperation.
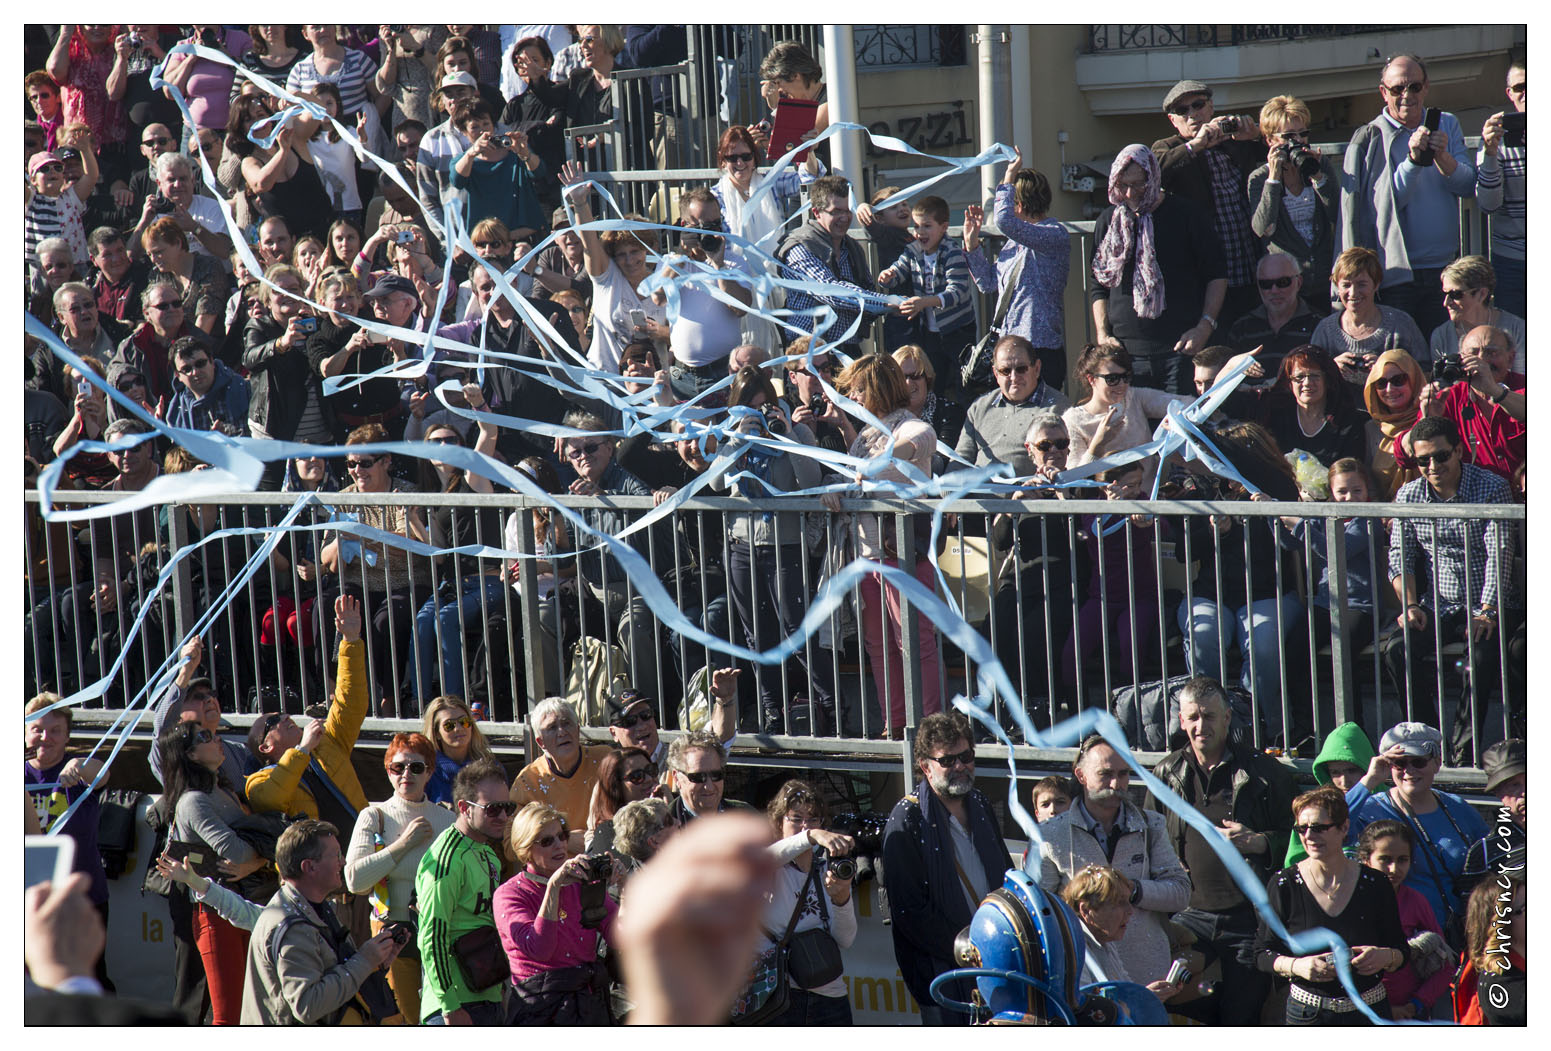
[25,493,1525,778]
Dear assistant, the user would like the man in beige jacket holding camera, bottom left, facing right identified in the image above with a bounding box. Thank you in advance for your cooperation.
[242,820,402,1026]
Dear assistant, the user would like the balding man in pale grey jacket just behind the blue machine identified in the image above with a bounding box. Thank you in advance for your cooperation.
[1024,733,1191,984]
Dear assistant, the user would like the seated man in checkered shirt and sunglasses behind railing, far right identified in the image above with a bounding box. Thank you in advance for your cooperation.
[1379,417,1525,766]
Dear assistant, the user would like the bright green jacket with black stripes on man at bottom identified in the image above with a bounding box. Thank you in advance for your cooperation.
[414,825,504,1022]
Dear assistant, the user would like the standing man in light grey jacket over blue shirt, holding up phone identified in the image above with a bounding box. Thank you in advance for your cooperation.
[1335,54,1475,332]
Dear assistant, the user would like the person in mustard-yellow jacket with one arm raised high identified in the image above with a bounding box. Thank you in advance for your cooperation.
[247,595,369,828]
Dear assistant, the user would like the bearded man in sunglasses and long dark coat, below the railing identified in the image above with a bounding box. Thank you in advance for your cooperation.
[883,712,1011,1025]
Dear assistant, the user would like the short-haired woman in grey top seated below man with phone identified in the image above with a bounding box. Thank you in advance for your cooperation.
[1309,248,1433,386]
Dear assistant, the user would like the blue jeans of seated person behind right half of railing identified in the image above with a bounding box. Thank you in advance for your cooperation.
[1179,594,1303,738]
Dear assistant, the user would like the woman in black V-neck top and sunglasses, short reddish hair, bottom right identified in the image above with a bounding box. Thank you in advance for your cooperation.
[1255,784,1410,1026]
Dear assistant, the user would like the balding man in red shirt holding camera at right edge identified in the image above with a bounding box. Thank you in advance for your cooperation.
[1419,326,1529,481]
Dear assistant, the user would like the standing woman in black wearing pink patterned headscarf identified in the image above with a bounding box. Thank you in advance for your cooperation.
[1089,144,1228,394]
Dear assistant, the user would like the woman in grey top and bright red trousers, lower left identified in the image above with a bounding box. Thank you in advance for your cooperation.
[157,722,268,1026]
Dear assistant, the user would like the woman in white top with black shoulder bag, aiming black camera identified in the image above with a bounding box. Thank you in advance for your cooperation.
[744,780,856,1026]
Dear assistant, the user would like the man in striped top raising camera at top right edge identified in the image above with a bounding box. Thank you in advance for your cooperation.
[1475,62,1529,318]
